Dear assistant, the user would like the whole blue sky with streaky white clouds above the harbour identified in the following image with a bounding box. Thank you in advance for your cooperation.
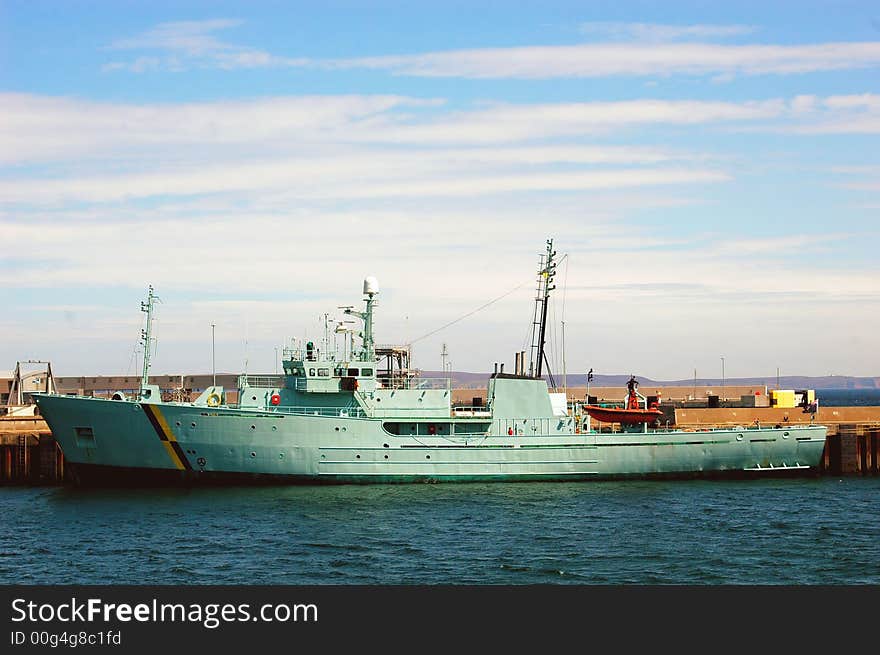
[0,0,880,380]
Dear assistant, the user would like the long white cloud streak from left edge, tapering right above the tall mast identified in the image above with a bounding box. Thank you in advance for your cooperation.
[0,152,728,205]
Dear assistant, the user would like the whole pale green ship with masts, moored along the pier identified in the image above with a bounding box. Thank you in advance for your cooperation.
[35,240,826,485]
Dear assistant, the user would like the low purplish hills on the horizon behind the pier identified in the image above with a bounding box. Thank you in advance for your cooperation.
[422,371,880,389]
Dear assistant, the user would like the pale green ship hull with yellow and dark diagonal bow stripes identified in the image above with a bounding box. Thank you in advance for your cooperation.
[38,395,826,484]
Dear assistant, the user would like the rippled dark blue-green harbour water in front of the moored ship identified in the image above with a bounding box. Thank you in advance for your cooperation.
[0,478,880,584]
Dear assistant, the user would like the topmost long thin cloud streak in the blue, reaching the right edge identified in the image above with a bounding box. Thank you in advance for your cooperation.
[103,19,880,80]
